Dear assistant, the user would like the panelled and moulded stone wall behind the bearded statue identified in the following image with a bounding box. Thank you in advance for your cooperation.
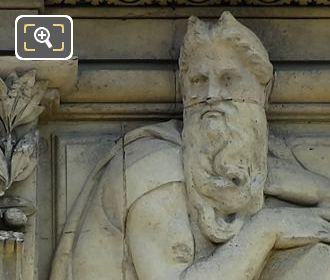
[0,0,330,280]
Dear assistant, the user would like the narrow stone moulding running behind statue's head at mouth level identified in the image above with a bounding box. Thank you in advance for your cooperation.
[41,103,330,122]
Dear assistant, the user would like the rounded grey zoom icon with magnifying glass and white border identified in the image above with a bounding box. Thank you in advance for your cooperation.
[15,15,73,60]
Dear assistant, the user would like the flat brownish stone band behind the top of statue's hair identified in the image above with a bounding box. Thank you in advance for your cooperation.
[74,18,330,61]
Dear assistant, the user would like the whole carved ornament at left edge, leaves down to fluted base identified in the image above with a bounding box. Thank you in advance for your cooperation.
[0,70,48,280]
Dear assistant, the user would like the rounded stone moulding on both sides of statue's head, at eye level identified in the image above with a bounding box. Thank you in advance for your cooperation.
[60,64,330,103]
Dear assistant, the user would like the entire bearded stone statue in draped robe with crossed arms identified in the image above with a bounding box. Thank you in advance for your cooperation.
[50,12,330,280]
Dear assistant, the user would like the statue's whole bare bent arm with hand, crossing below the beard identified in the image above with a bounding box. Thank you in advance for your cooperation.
[127,183,330,280]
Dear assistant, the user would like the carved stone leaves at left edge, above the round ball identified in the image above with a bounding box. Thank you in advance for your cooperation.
[0,70,48,196]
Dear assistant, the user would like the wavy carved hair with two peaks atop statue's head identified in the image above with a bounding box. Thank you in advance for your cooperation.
[179,12,273,86]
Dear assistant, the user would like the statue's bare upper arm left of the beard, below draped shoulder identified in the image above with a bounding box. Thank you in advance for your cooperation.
[126,182,194,280]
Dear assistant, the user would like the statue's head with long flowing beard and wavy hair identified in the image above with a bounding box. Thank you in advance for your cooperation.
[179,12,273,242]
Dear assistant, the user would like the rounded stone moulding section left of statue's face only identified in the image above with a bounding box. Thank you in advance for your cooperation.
[65,70,176,103]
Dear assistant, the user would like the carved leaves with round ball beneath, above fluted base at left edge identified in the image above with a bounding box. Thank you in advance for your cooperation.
[0,70,48,232]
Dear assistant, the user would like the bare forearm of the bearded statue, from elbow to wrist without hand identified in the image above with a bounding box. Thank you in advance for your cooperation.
[179,212,276,280]
